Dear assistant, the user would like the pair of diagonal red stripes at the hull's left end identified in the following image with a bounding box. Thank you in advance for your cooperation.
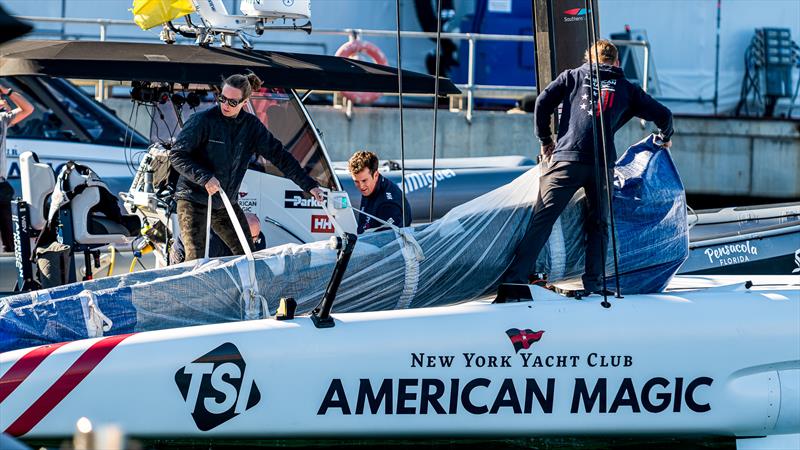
[0,334,132,436]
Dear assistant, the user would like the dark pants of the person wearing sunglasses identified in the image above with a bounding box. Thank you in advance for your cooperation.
[178,200,253,261]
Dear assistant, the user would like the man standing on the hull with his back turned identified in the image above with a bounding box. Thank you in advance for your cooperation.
[504,40,673,294]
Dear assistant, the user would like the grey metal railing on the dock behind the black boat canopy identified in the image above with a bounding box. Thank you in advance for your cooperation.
[18,16,650,122]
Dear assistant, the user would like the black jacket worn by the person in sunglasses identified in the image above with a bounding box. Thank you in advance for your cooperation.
[169,107,318,209]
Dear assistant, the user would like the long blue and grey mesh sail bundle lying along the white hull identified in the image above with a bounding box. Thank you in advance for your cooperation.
[0,137,688,351]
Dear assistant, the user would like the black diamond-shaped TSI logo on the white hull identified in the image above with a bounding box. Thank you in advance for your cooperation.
[175,342,261,431]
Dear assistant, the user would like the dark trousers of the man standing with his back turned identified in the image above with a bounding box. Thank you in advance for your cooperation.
[504,161,611,291]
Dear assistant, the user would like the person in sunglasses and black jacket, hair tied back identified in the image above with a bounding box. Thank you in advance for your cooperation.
[170,74,323,261]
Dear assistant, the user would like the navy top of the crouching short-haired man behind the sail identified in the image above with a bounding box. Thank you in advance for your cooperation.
[357,174,411,234]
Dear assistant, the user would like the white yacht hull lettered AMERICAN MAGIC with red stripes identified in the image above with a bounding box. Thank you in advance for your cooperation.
[0,277,800,438]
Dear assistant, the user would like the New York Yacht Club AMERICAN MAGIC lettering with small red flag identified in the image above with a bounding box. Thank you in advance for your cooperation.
[317,328,714,416]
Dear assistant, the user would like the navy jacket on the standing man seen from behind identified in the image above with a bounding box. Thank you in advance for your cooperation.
[534,63,673,167]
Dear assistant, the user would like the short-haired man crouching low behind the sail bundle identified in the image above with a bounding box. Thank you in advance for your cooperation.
[347,151,411,234]
